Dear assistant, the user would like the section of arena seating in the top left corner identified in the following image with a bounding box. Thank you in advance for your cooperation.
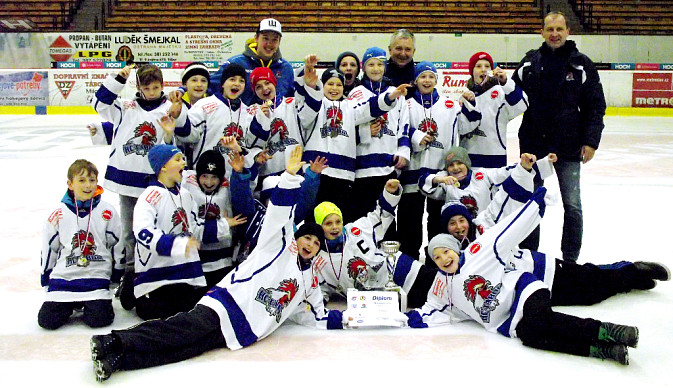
[0,0,82,31]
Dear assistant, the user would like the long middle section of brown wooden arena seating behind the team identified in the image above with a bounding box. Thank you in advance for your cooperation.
[105,0,541,33]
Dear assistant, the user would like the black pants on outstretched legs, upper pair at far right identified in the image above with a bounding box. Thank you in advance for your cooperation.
[551,259,652,306]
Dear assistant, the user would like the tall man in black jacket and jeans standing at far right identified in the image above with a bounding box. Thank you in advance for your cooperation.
[512,12,605,261]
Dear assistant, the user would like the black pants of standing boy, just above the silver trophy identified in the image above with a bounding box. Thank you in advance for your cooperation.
[397,192,446,264]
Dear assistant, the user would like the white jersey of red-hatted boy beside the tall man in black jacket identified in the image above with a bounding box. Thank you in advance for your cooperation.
[460,78,528,168]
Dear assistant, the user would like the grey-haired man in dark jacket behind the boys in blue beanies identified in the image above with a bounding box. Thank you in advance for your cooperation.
[384,29,416,98]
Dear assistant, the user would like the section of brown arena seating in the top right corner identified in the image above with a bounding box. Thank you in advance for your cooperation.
[575,0,673,35]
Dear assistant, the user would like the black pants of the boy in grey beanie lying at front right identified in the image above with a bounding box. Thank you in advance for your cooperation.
[516,289,601,356]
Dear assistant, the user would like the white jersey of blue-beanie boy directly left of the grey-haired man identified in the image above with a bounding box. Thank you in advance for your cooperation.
[348,81,411,178]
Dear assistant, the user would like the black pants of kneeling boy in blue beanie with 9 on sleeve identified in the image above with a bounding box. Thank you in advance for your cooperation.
[136,283,208,320]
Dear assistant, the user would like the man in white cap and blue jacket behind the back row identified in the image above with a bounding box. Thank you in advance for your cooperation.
[210,18,294,106]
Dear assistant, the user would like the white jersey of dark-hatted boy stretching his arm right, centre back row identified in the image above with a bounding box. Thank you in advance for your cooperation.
[298,82,396,181]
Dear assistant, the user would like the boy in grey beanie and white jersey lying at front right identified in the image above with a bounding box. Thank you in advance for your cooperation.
[407,188,670,365]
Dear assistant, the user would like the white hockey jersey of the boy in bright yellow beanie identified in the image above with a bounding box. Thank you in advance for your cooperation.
[313,189,402,299]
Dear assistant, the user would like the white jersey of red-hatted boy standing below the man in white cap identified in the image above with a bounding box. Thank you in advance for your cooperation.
[246,97,302,179]
